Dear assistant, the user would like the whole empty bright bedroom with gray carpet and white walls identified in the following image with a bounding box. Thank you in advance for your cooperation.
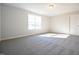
[0,3,79,55]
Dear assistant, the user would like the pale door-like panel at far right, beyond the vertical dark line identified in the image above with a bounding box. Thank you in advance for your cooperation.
[70,14,79,35]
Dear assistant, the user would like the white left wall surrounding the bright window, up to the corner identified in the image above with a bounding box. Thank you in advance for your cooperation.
[1,5,49,40]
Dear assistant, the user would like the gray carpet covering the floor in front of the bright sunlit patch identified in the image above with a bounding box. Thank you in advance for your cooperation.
[0,35,79,55]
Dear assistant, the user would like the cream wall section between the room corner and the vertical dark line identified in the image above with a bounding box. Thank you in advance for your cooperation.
[51,15,69,33]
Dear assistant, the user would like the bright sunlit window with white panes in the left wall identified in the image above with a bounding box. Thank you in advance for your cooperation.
[28,14,41,30]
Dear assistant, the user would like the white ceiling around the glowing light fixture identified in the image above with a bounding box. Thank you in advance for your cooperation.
[4,3,79,16]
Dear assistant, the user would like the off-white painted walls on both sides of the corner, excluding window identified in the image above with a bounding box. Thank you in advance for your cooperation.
[1,4,79,40]
